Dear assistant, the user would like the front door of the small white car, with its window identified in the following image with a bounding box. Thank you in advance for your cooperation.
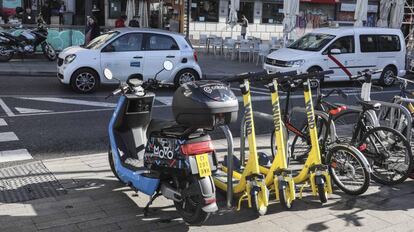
[101,33,145,81]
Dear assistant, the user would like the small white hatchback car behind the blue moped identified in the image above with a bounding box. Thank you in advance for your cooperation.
[58,28,202,93]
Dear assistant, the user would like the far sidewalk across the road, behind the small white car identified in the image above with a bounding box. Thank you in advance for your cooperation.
[0,52,262,79]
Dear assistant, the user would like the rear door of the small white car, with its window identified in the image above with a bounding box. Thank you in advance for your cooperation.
[144,33,180,82]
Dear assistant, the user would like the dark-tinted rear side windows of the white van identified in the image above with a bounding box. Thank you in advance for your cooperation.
[359,35,401,52]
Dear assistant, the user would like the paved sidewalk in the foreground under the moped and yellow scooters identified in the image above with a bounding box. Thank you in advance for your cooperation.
[0,136,414,232]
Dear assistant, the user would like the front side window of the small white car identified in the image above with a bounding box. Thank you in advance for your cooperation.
[105,33,142,52]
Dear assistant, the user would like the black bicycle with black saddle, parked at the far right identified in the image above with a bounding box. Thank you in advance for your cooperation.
[333,70,413,185]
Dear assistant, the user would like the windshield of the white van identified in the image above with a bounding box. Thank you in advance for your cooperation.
[288,33,335,52]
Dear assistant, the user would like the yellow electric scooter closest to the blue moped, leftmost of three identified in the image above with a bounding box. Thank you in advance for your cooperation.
[213,71,290,215]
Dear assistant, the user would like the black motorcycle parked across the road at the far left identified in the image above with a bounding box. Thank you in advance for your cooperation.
[0,17,57,62]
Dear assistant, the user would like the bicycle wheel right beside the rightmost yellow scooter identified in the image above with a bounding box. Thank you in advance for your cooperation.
[325,144,371,195]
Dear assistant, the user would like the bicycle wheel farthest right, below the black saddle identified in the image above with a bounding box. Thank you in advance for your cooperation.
[357,127,413,185]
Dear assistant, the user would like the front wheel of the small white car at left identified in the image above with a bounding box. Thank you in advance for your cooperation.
[70,68,99,93]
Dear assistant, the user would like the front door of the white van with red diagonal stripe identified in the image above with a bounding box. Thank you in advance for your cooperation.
[323,35,358,81]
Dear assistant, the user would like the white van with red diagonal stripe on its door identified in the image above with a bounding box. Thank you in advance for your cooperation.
[264,27,406,86]
